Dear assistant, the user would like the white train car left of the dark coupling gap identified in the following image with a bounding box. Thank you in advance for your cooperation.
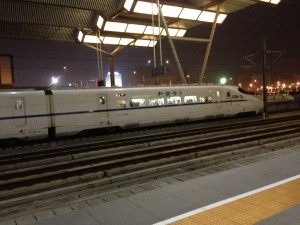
[0,91,49,139]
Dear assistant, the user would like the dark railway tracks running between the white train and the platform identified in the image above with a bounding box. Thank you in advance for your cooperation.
[0,115,300,219]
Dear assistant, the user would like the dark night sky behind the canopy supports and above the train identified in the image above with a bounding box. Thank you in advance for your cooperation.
[0,0,300,87]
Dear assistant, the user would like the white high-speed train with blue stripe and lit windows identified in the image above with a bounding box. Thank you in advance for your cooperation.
[0,85,263,140]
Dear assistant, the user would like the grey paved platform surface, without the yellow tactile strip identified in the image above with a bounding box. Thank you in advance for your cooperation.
[0,146,300,225]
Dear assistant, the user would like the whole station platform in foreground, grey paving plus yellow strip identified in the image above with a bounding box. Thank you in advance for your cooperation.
[0,146,300,225]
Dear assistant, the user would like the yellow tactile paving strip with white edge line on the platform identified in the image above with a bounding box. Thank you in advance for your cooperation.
[156,175,300,225]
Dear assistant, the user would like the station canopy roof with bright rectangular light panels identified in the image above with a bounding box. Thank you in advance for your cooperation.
[0,0,280,47]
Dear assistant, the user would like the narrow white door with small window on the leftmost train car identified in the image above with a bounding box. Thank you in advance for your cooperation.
[12,98,26,127]
